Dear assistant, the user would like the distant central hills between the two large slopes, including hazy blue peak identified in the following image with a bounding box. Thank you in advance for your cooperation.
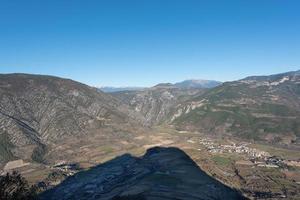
[106,80,221,125]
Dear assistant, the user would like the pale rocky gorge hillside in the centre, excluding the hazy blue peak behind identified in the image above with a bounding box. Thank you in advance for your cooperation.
[111,84,204,125]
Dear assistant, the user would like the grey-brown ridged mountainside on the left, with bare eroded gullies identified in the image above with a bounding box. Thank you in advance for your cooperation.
[0,74,144,165]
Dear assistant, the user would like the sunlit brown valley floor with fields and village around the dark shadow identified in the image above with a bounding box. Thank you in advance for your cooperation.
[1,127,300,199]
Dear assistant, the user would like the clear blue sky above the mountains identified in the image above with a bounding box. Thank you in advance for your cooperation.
[0,0,300,86]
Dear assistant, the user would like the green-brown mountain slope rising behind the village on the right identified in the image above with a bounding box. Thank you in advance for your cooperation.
[170,71,300,144]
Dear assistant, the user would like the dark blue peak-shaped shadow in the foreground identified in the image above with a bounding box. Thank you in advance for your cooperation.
[41,147,245,200]
